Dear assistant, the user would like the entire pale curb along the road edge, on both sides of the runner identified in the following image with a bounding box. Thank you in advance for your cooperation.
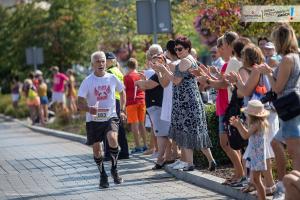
[0,114,256,200]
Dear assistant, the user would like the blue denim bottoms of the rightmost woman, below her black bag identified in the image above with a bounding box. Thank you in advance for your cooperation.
[275,115,300,141]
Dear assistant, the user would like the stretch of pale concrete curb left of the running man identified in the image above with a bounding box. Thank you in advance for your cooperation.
[0,114,86,144]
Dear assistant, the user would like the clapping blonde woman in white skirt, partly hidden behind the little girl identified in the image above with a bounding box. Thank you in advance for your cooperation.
[228,44,278,195]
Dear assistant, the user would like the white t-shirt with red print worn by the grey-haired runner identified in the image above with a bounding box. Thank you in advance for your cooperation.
[78,73,124,122]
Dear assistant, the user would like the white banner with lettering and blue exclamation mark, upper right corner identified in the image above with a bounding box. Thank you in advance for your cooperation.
[241,5,300,22]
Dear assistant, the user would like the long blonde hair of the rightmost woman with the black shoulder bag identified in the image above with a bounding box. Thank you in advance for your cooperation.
[271,23,298,55]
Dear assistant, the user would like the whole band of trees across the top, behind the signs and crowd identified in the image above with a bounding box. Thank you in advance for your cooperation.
[0,0,300,91]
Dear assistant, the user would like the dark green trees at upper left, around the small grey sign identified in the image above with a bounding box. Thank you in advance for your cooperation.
[0,0,98,92]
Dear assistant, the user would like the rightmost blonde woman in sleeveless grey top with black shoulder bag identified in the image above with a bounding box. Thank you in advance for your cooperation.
[255,24,300,170]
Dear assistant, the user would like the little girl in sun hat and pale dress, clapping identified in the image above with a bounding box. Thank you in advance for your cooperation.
[230,100,269,200]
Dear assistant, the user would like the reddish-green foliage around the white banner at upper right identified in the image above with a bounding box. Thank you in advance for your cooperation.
[196,0,300,47]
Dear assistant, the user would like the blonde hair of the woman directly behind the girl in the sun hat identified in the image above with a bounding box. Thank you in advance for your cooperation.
[241,43,265,67]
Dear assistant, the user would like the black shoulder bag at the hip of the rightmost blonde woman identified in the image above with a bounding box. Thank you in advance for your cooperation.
[273,91,300,121]
